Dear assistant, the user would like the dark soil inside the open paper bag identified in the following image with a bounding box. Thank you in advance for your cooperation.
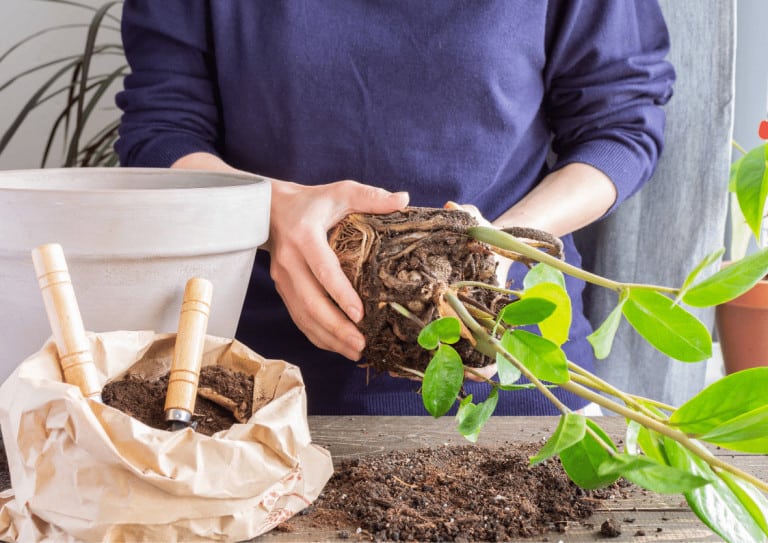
[101,366,254,435]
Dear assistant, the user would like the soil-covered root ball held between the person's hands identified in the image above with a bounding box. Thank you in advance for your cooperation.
[328,207,562,376]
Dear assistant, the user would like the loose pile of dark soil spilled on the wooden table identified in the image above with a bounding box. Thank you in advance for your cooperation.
[288,444,623,542]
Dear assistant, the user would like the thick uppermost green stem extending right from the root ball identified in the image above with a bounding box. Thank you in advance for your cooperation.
[467,226,679,294]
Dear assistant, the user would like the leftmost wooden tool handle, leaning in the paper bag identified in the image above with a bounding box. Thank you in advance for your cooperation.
[32,243,101,401]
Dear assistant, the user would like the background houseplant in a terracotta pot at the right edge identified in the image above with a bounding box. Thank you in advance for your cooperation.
[715,121,768,373]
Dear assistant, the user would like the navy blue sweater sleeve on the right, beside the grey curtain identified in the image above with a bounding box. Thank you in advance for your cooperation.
[545,0,675,213]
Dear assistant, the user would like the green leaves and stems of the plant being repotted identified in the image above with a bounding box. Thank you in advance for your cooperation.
[418,219,768,543]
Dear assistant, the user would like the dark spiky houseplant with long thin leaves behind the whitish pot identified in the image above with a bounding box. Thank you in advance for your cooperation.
[0,0,128,167]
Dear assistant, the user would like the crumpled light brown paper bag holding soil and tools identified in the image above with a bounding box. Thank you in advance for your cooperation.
[0,332,333,542]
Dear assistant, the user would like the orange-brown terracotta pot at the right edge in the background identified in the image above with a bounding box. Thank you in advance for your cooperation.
[715,280,768,374]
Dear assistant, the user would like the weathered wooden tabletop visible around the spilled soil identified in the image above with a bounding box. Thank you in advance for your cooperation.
[253,417,768,543]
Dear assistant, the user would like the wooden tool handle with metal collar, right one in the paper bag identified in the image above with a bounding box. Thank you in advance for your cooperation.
[165,277,213,423]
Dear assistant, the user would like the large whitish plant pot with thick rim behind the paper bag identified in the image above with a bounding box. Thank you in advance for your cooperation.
[0,168,271,383]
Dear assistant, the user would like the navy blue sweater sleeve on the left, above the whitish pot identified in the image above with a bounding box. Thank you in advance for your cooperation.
[115,0,219,167]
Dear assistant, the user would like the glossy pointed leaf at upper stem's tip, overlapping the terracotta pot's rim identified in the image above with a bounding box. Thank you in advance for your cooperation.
[683,247,768,307]
